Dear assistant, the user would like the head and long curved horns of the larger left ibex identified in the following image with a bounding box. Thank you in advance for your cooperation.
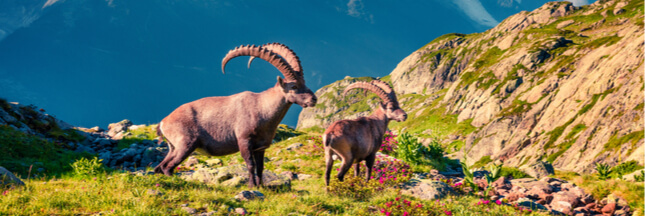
[222,43,318,108]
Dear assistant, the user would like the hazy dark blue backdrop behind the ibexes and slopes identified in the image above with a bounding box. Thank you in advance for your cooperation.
[0,0,590,128]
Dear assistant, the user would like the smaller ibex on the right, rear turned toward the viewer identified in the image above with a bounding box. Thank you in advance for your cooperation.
[323,80,408,186]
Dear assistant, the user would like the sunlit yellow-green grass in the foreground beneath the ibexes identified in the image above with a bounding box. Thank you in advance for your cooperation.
[0,126,552,215]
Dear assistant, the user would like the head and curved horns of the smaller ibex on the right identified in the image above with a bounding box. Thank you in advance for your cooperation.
[343,80,408,122]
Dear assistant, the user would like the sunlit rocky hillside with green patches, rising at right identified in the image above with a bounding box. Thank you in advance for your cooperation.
[298,0,645,172]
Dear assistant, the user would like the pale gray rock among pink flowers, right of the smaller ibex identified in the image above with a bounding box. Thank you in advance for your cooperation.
[401,179,455,200]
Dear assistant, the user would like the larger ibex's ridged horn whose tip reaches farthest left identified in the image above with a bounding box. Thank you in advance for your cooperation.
[222,45,297,80]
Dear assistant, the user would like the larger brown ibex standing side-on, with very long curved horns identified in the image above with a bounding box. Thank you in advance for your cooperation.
[155,43,317,187]
